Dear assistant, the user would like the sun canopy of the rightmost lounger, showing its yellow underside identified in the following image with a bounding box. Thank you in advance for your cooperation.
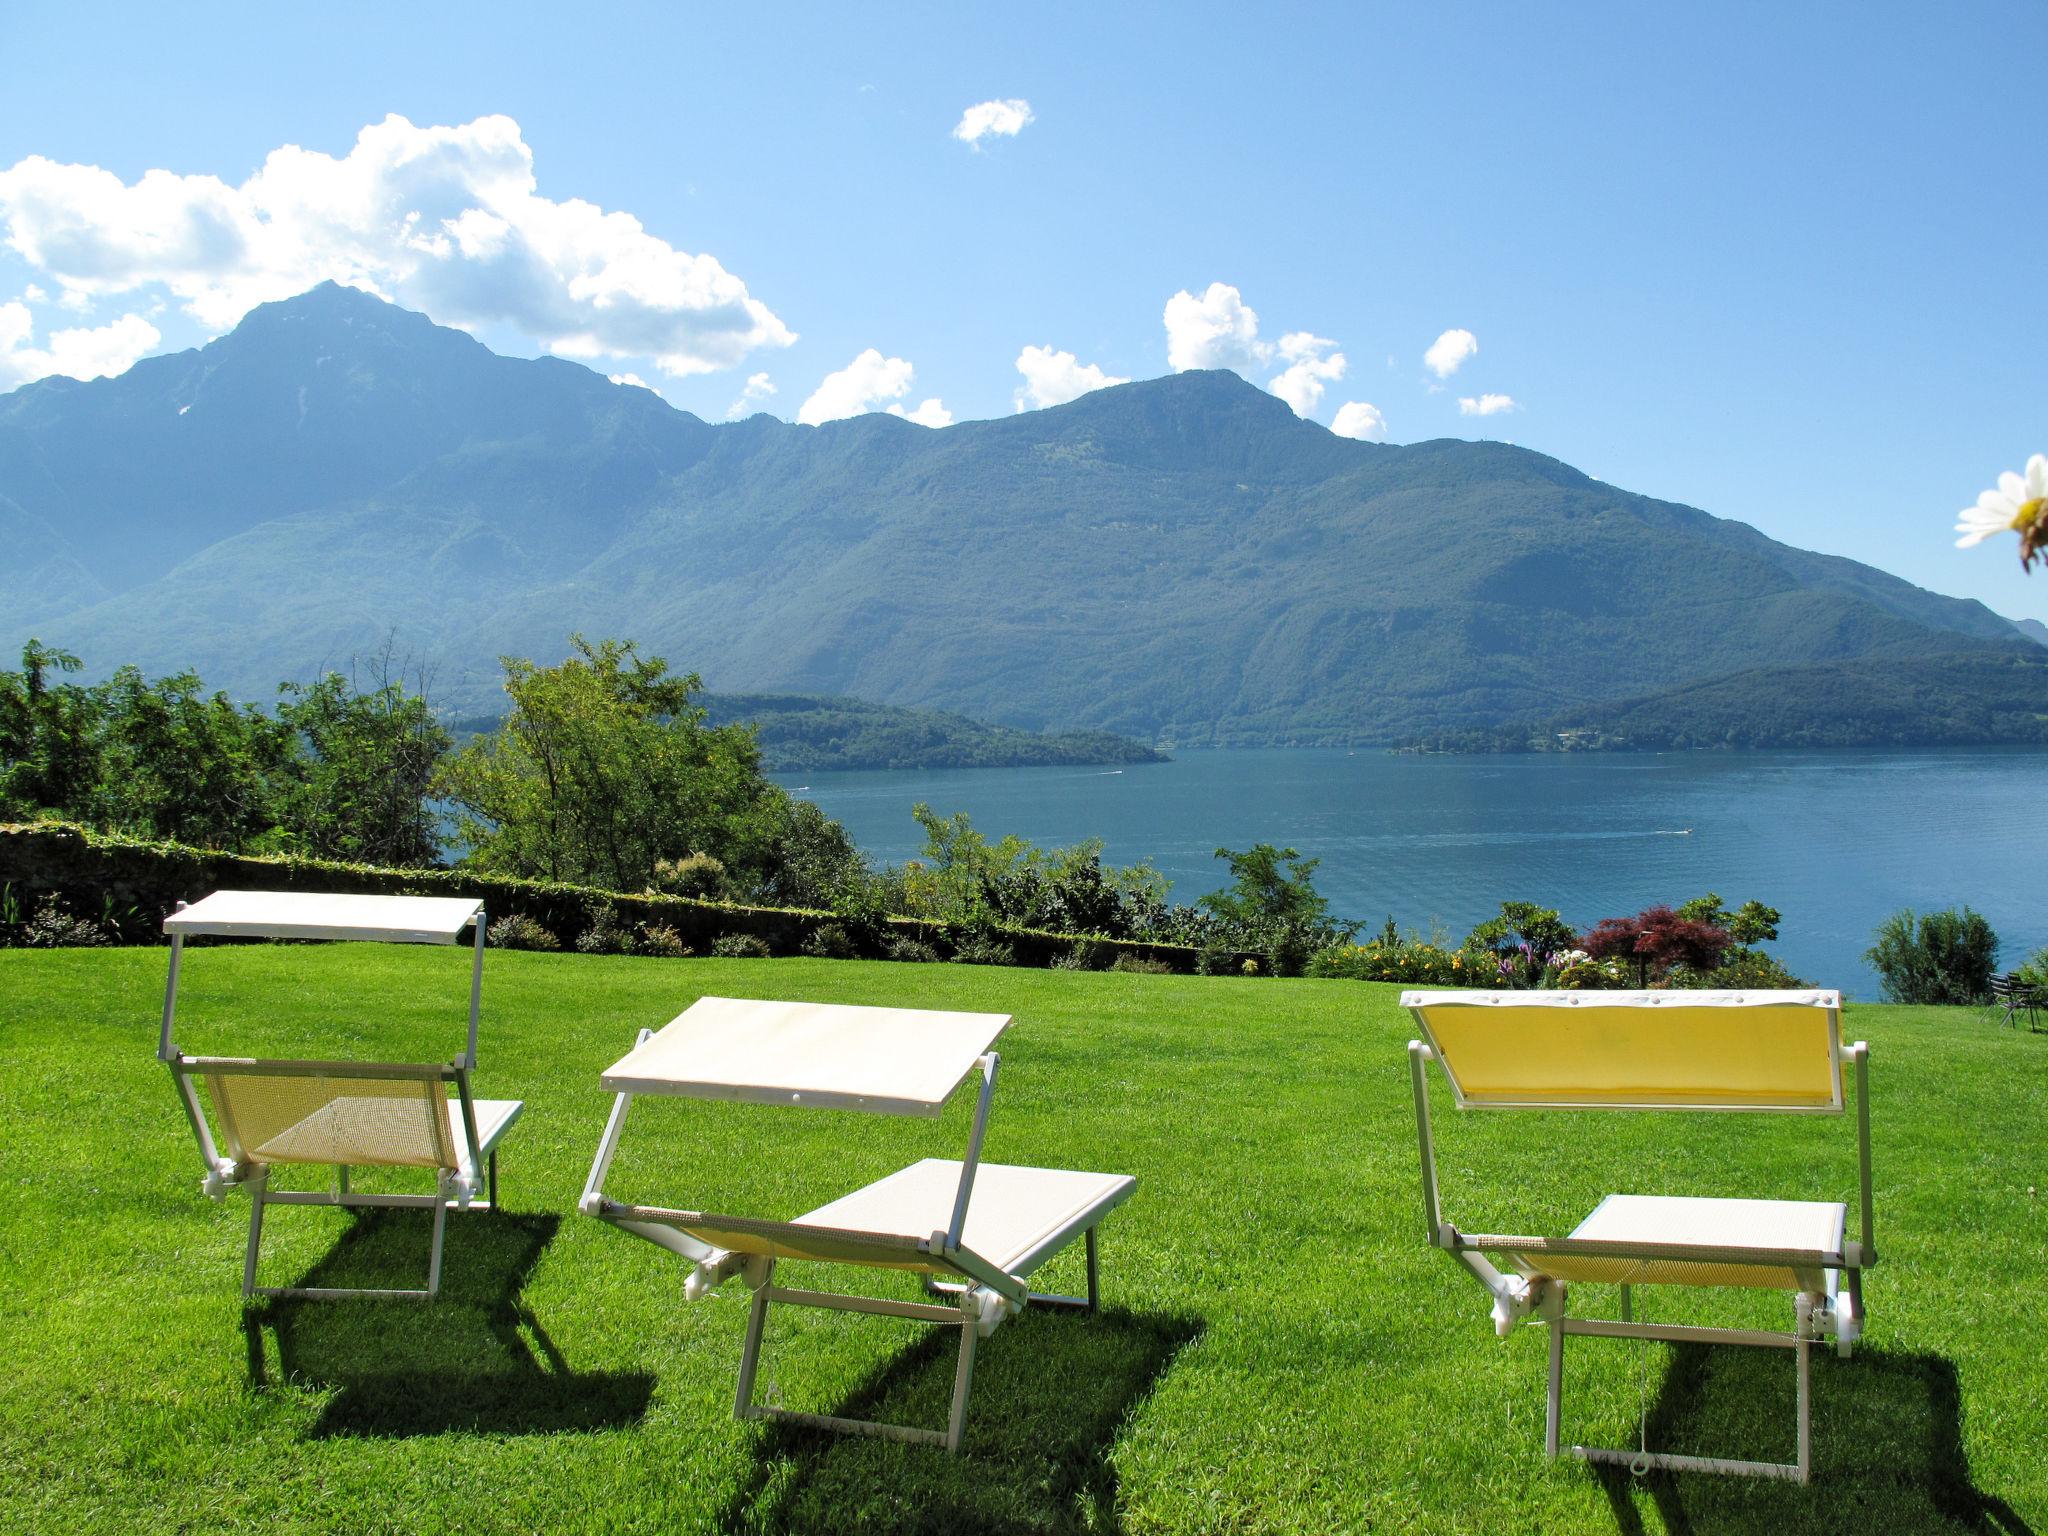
[1401,991,1841,1112]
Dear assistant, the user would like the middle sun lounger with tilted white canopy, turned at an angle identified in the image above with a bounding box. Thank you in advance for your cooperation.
[582,997,1137,1452]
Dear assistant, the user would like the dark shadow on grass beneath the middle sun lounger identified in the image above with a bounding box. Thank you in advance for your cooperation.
[721,1309,1204,1536]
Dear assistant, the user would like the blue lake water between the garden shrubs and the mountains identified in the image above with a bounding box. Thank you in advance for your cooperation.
[780,748,2048,997]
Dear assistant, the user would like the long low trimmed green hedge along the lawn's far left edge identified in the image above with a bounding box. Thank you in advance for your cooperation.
[0,821,1196,971]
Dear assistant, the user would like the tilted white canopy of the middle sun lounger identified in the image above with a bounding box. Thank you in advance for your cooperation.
[604,997,1010,1116]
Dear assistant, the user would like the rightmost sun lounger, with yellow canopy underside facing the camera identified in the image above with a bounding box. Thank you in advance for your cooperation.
[1401,991,1878,1483]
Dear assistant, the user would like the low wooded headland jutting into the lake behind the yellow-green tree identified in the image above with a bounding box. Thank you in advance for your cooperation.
[705,694,1165,774]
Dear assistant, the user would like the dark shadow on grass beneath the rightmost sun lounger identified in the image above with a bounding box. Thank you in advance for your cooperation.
[1589,1343,2034,1536]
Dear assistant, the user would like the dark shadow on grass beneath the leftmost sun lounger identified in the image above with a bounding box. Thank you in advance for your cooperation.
[244,1210,653,1438]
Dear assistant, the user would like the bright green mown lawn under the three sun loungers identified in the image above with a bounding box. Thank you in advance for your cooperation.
[0,946,2048,1536]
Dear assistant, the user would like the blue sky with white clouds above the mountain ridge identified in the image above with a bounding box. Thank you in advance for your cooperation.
[0,0,2048,616]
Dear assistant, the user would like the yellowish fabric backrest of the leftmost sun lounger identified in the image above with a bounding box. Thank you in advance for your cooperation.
[205,1063,457,1169]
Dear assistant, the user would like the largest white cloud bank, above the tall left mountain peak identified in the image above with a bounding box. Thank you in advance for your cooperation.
[0,115,797,375]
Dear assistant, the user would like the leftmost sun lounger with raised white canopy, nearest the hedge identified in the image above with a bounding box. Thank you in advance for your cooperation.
[158,891,524,1300]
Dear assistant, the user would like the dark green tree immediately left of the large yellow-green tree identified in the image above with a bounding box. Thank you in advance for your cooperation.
[276,666,449,864]
